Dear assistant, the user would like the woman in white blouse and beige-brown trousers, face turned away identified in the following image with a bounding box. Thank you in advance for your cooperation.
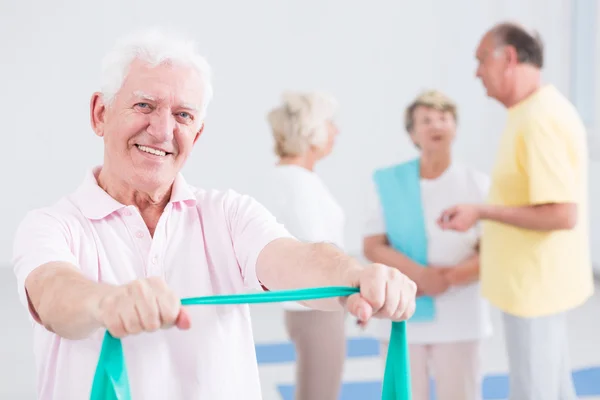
[256,92,346,400]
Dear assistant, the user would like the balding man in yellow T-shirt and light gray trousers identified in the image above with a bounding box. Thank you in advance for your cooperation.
[439,23,594,400]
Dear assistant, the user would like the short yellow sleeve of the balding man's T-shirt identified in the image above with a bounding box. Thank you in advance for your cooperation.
[519,121,579,204]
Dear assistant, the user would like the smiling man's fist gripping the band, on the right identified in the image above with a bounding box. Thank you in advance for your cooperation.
[346,264,417,324]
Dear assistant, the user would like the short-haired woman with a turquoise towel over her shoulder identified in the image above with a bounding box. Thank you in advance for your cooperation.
[363,91,492,400]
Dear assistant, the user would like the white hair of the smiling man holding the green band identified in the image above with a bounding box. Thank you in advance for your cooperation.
[101,29,213,118]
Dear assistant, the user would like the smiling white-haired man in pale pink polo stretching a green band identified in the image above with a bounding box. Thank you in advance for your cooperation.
[14,33,416,400]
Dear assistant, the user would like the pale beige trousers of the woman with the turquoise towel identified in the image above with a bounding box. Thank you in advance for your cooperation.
[381,341,482,400]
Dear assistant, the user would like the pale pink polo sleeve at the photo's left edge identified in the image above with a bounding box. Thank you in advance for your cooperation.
[12,210,77,307]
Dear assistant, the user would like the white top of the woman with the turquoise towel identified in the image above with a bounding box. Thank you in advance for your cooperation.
[364,163,492,344]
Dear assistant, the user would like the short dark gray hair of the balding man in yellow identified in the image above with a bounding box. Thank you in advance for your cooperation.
[490,22,544,69]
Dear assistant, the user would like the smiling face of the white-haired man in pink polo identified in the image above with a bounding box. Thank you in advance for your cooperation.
[91,60,204,191]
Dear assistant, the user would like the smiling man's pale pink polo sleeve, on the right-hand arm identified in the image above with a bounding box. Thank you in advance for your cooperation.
[226,193,293,288]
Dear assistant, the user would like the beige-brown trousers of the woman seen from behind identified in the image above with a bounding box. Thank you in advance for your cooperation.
[285,310,346,400]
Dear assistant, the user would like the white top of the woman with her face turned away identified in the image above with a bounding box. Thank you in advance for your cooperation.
[255,165,344,310]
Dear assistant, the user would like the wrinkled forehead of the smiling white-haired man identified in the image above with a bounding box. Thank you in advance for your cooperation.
[120,61,205,110]
